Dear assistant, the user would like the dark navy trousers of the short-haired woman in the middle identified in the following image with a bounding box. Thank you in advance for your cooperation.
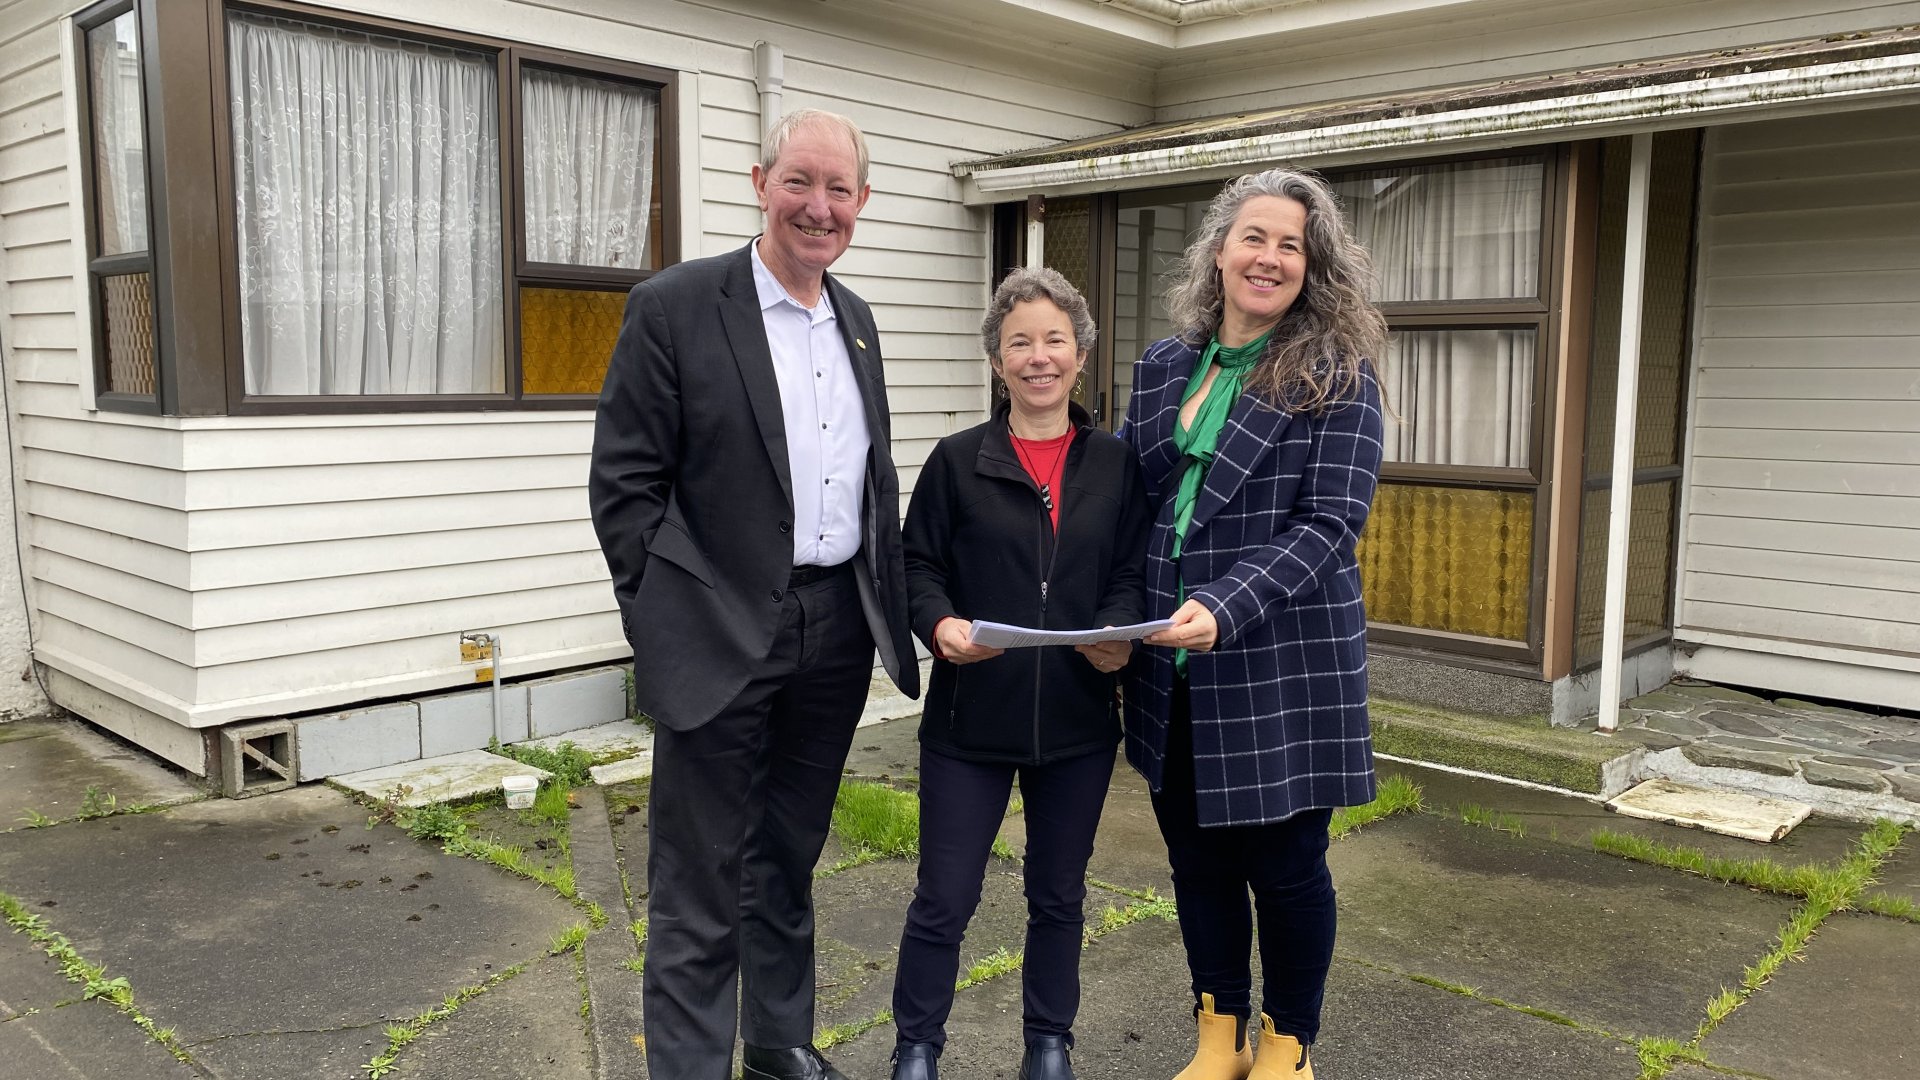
[893,748,1114,1045]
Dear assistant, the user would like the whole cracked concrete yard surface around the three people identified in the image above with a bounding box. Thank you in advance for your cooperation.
[0,707,1920,1080]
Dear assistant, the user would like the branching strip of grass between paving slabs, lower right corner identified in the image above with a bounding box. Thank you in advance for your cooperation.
[1628,819,1907,1080]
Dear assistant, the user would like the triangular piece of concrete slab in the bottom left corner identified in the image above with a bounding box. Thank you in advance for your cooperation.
[0,934,196,1080]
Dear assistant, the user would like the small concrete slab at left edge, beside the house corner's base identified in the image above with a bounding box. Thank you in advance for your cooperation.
[0,717,205,830]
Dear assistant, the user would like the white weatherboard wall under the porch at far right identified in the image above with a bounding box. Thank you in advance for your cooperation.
[1676,108,1920,707]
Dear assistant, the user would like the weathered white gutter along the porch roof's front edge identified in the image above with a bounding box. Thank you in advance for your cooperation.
[952,44,1920,204]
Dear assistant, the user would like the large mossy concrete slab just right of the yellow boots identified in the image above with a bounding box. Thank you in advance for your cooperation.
[1329,815,1793,1038]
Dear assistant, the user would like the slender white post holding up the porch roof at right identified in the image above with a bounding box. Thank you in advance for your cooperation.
[1599,133,1653,732]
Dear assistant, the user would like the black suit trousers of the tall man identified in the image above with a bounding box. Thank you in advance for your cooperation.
[643,563,874,1080]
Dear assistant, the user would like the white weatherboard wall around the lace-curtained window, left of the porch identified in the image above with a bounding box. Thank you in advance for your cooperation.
[0,0,1150,726]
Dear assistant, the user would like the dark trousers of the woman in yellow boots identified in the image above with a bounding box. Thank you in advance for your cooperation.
[1154,680,1334,1043]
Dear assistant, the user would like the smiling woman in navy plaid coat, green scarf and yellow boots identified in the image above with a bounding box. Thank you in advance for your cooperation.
[1121,169,1386,1080]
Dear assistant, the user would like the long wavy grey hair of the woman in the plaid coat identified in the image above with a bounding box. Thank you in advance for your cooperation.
[1167,169,1386,413]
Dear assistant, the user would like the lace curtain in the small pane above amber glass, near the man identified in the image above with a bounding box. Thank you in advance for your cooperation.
[520,67,660,269]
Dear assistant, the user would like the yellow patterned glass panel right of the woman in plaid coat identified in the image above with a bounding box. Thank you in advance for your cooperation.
[1357,484,1534,642]
